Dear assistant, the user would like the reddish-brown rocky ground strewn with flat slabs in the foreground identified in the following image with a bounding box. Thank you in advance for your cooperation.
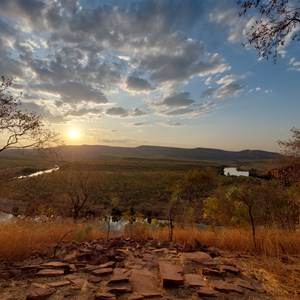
[0,238,295,300]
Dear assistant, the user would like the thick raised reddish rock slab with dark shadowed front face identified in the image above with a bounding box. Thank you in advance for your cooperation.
[158,261,183,287]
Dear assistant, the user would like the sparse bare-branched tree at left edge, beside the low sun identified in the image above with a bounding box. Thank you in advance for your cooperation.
[0,76,59,152]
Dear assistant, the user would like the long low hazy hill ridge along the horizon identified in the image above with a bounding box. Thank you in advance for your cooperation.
[0,145,279,161]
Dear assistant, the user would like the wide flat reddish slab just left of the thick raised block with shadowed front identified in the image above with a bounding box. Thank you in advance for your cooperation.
[129,269,159,295]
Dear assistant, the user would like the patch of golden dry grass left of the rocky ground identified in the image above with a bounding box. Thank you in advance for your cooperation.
[0,220,104,261]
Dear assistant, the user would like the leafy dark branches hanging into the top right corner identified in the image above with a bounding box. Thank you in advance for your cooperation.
[237,0,300,62]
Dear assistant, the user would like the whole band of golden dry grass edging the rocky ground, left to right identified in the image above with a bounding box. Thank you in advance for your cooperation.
[0,220,300,295]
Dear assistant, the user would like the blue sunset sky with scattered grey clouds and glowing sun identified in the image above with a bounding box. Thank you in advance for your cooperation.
[0,0,300,151]
